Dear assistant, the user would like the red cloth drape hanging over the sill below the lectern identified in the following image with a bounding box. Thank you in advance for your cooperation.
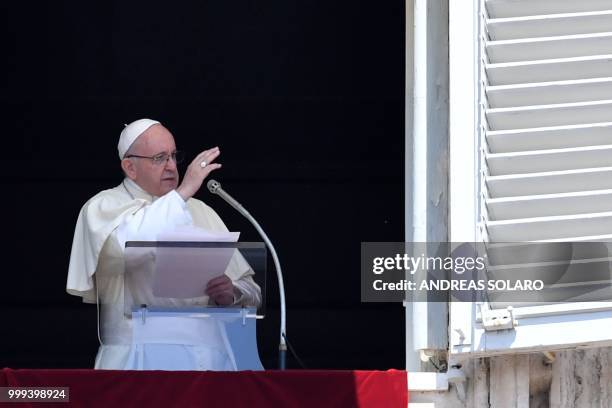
[0,368,408,408]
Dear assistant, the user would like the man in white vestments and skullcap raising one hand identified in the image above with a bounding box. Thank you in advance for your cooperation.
[66,119,261,370]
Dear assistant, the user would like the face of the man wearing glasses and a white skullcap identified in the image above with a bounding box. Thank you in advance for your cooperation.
[123,124,179,196]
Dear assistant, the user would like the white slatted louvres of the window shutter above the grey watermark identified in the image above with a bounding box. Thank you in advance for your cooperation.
[481,0,612,242]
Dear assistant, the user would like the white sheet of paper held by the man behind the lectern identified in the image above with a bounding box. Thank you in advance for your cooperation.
[153,226,240,298]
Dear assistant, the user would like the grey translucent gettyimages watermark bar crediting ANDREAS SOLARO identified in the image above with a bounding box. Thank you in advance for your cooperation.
[361,242,612,303]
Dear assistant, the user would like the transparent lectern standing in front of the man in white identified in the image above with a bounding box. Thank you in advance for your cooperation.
[97,241,267,371]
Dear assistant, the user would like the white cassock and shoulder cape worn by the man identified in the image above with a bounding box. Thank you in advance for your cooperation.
[66,178,261,370]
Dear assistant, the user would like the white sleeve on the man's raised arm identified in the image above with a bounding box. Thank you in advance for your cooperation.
[117,190,193,249]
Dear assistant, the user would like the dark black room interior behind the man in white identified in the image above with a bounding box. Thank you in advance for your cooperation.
[0,0,405,369]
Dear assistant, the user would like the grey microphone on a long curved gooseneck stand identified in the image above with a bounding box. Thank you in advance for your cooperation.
[206,179,287,370]
